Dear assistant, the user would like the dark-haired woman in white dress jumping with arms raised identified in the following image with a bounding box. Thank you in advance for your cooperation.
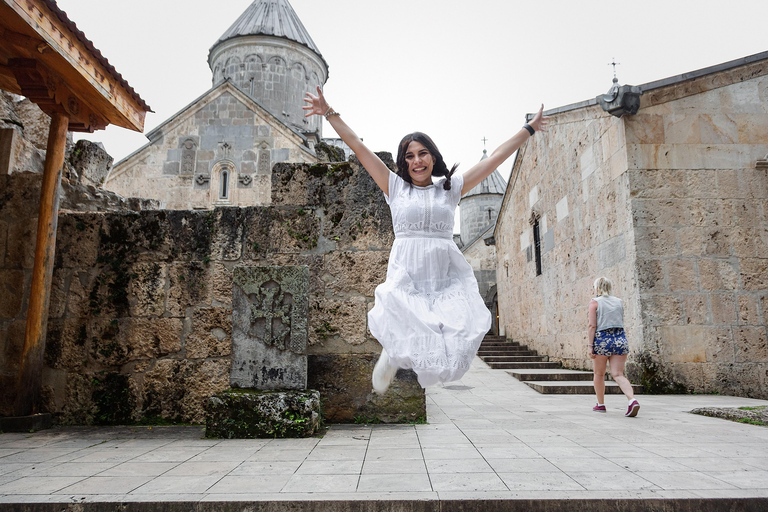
[304,87,547,393]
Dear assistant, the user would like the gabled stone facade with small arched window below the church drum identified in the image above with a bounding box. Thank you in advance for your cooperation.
[104,82,317,210]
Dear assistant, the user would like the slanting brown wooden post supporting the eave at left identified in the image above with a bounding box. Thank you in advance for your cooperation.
[15,113,69,416]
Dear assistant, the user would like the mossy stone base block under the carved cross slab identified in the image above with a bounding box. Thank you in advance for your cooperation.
[205,389,322,439]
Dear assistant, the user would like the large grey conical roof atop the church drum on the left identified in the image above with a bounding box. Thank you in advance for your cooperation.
[212,0,321,55]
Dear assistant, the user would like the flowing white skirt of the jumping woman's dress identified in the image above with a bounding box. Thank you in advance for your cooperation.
[368,238,491,387]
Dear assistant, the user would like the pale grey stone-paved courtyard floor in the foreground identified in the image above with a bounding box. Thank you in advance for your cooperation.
[0,359,768,512]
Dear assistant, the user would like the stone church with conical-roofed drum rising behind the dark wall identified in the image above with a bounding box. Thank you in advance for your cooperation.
[104,0,328,210]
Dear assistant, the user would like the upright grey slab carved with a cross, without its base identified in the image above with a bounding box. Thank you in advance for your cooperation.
[230,266,309,390]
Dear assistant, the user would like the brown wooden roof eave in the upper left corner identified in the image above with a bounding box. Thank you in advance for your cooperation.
[0,0,151,132]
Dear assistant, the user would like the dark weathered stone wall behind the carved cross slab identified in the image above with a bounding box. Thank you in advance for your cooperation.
[0,154,425,424]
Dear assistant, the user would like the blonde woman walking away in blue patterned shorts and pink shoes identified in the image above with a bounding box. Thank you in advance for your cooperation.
[587,277,640,417]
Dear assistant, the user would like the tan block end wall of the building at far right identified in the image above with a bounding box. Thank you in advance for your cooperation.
[626,70,768,398]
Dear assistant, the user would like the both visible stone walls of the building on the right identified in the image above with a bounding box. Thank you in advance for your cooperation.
[495,56,768,398]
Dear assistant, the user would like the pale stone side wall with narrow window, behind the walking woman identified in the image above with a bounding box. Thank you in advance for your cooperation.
[495,107,642,374]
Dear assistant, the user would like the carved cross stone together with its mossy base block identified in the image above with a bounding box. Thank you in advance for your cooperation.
[206,266,321,438]
